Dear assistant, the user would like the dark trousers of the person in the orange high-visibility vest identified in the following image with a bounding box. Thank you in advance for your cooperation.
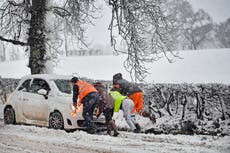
[82,92,99,128]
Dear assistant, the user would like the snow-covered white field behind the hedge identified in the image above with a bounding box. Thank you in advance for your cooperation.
[0,49,230,84]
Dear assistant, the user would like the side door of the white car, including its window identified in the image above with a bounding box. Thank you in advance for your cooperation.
[22,78,50,121]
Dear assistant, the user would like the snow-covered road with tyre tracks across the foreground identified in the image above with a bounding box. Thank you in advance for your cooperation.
[0,120,230,153]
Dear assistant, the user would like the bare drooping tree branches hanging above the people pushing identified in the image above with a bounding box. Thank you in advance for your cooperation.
[109,0,172,80]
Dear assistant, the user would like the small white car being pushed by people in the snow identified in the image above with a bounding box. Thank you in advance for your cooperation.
[4,74,104,130]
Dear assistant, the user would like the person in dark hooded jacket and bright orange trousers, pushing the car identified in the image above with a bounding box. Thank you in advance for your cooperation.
[113,73,155,133]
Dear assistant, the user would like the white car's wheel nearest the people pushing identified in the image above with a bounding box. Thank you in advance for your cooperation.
[49,112,64,130]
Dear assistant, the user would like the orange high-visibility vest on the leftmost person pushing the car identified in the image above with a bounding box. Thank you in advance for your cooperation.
[76,80,98,103]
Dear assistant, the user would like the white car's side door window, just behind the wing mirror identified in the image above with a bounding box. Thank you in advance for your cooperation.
[30,79,50,94]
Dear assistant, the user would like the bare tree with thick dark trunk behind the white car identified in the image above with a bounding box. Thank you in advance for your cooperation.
[0,0,96,74]
